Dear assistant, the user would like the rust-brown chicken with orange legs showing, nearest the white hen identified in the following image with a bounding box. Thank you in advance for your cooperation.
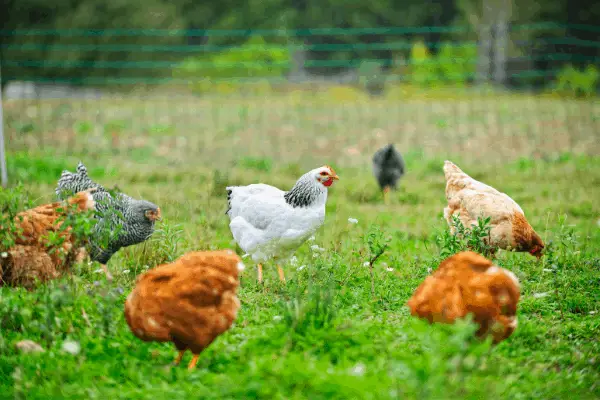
[125,250,244,369]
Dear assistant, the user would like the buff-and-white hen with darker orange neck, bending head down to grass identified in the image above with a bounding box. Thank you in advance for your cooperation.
[444,161,544,259]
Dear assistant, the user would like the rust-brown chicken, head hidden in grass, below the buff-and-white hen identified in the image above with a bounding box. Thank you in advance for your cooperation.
[408,251,520,343]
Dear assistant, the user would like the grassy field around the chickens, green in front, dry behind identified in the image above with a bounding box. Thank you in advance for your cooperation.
[0,89,600,399]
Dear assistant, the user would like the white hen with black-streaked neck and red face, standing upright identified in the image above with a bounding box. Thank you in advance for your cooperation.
[226,165,339,282]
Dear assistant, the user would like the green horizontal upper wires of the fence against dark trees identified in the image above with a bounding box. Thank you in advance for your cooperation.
[0,22,600,87]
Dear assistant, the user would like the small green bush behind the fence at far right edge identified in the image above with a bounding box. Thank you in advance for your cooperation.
[554,64,600,97]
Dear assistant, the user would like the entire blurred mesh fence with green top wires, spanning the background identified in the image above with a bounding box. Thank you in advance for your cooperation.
[0,24,600,180]
